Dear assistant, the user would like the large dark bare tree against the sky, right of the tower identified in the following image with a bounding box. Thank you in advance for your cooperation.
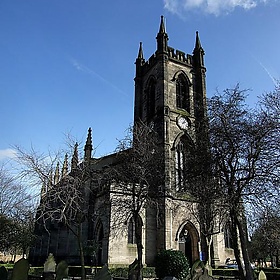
[208,85,279,280]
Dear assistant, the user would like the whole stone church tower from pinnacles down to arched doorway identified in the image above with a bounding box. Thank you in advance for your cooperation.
[134,17,207,262]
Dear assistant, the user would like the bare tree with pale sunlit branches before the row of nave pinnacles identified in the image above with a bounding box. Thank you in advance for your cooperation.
[14,145,90,279]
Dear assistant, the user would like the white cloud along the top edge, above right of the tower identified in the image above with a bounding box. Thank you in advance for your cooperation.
[164,0,269,15]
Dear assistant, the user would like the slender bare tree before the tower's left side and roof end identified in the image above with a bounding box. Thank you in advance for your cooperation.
[108,123,164,279]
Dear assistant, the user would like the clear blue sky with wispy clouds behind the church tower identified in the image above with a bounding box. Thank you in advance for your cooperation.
[0,0,280,161]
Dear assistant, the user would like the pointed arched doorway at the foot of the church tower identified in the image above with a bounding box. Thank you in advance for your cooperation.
[176,221,199,264]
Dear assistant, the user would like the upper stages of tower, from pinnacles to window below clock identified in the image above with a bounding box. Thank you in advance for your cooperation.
[134,16,206,193]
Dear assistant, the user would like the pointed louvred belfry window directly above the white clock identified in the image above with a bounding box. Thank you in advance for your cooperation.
[176,74,190,112]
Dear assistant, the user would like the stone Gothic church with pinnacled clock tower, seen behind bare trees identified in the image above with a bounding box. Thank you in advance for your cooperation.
[30,17,233,266]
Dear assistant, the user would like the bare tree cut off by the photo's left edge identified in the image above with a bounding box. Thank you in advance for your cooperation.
[0,165,35,256]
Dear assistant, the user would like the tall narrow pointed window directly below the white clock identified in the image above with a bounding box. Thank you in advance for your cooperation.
[175,141,185,191]
